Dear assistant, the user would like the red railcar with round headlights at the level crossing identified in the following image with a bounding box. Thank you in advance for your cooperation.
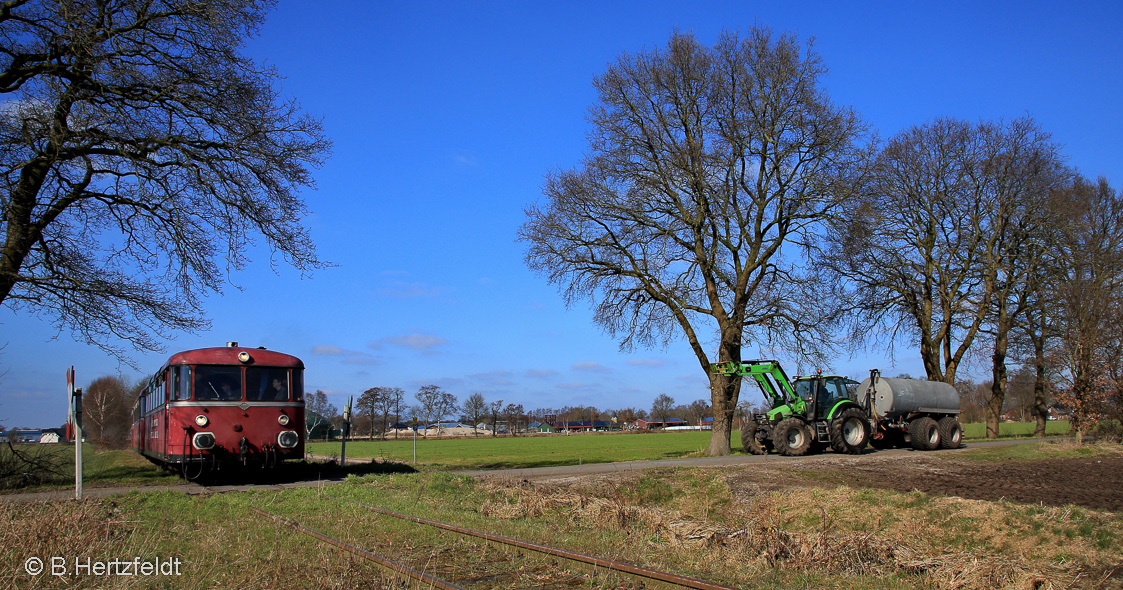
[131,343,304,479]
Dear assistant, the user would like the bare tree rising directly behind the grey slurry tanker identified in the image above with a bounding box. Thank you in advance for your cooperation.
[819,119,989,384]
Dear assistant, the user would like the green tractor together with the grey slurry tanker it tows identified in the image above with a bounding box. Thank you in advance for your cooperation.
[711,361,962,456]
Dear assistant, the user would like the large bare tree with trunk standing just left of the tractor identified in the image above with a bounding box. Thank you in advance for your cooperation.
[519,27,865,455]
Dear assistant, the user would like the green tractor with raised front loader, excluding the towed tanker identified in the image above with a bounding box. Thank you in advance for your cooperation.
[710,361,871,456]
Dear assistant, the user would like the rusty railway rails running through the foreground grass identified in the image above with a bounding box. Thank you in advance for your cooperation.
[254,496,736,590]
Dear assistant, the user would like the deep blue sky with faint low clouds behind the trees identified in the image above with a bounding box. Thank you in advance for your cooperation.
[0,0,1123,427]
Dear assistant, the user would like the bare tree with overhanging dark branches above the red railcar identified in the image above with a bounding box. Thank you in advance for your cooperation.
[0,0,329,356]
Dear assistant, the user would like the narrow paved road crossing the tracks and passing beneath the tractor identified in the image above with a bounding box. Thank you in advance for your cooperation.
[0,438,1063,501]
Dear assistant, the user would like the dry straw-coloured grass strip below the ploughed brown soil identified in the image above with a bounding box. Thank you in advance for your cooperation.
[481,472,1123,590]
